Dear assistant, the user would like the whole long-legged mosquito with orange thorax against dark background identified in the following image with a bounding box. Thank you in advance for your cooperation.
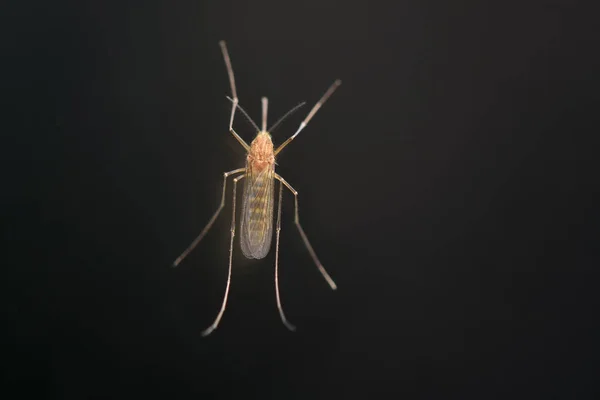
[173,41,342,336]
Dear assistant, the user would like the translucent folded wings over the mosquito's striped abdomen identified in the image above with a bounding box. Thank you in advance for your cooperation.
[240,166,275,259]
